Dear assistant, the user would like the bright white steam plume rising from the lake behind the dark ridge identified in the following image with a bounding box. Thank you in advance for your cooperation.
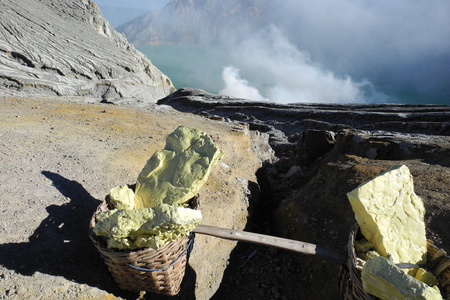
[220,26,387,103]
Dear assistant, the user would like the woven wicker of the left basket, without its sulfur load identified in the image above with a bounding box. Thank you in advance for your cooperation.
[89,201,194,296]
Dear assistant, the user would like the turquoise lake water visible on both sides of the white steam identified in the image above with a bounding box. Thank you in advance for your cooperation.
[135,45,450,105]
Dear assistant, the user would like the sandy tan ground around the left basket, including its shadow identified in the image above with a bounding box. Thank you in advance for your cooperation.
[0,97,269,299]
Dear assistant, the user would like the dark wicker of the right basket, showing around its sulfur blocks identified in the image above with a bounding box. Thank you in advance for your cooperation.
[339,224,450,300]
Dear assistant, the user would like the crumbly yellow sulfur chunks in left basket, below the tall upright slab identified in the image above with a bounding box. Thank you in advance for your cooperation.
[94,204,202,249]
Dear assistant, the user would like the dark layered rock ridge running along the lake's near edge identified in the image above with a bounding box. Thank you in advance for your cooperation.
[158,88,450,151]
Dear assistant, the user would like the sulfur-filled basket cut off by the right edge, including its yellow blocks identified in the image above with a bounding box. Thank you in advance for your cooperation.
[339,166,450,300]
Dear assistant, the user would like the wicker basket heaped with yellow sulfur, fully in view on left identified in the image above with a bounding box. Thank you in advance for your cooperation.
[89,126,223,296]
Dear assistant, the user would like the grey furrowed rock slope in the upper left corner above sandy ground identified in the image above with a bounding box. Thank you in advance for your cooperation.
[0,0,175,102]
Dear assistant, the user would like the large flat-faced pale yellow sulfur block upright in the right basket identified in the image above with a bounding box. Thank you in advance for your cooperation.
[347,166,427,275]
